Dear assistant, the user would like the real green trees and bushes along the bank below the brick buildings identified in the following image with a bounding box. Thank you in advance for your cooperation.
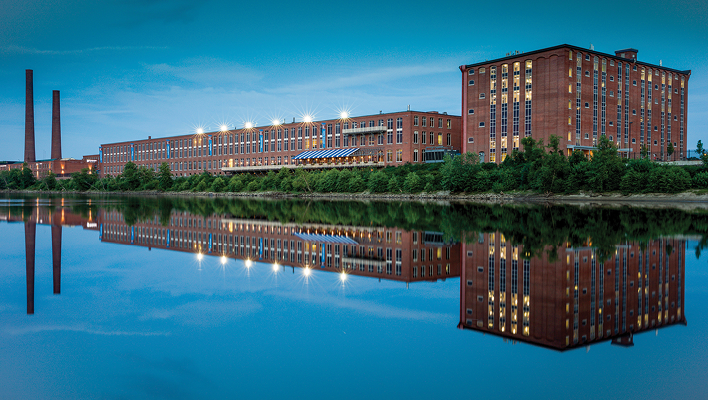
[0,136,708,194]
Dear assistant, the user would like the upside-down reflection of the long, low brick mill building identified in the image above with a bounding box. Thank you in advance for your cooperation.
[99,210,460,283]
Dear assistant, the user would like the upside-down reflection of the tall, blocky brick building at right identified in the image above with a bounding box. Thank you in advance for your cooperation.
[459,232,686,350]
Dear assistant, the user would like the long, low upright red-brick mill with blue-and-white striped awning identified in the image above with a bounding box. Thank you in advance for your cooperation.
[99,111,461,176]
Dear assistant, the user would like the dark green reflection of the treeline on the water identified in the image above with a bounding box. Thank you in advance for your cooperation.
[5,192,708,257]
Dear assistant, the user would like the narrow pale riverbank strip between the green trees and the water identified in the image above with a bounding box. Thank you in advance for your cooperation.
[0,190,708,209]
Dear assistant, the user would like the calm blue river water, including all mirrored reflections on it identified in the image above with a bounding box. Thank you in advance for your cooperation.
[0,195,708,399]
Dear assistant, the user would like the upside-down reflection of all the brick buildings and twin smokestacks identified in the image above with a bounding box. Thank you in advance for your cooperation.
[0,198,693,350]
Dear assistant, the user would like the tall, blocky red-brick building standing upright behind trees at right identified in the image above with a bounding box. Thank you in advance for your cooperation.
[460,45,691,162]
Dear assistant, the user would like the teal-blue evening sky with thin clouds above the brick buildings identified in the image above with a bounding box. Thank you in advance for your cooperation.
[0,0,708,160]
